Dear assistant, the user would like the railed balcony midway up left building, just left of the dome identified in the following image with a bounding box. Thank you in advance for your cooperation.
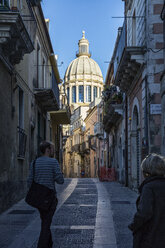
[34,72,59,112]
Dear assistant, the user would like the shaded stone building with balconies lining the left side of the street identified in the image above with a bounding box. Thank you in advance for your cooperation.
[0,0,65,211]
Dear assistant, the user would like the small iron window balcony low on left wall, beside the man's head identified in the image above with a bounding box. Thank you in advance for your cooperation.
[17,127,27,159]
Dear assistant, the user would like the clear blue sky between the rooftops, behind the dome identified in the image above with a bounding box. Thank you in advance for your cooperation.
[41,0,124,81]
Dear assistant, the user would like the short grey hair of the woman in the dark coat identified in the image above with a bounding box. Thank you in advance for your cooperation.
[141,153,165,176]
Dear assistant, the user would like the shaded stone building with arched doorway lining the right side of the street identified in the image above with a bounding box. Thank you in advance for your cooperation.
[103,0,164,188]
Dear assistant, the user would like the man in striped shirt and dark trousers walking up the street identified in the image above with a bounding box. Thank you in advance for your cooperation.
[27,141,64,248]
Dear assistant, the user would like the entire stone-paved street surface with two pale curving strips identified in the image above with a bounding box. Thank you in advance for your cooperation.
[0,178,137,248]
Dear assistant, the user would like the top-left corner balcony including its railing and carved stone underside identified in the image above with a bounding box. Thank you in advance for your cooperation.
[0,0,34,66]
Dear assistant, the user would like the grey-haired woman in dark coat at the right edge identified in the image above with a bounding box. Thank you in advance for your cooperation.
[129,153,165,248]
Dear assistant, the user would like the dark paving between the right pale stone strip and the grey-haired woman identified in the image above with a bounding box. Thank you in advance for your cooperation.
[103,182,138,248]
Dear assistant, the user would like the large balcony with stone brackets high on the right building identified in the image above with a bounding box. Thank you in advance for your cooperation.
[114,22,146,92]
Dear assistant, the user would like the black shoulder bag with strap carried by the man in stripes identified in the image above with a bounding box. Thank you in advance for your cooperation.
[25,160,55,210]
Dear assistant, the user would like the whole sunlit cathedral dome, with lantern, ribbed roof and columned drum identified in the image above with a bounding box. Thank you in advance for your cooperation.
[64,31,103,108]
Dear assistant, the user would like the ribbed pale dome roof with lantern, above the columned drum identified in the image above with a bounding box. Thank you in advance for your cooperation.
[65,31,103,82]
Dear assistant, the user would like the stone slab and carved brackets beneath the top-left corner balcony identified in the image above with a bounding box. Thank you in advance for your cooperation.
[0,12,34,65]
